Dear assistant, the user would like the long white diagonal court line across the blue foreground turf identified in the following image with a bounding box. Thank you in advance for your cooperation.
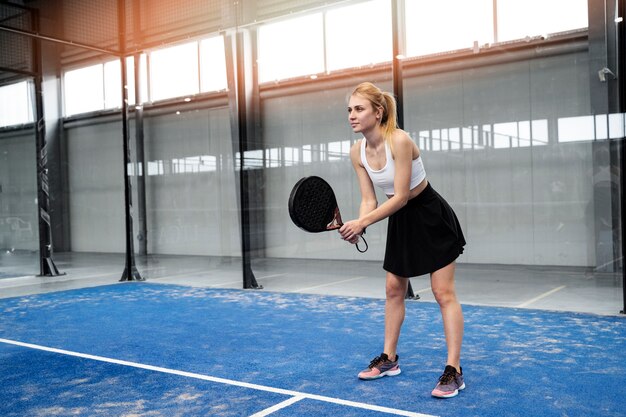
[0,338,434,417]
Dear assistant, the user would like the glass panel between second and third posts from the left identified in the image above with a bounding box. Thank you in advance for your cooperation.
[133,106,243,288]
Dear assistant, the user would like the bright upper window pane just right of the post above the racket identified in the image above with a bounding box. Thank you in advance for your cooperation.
[258,13,324,82]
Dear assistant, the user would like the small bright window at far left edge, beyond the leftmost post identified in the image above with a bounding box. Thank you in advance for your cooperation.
[0,81,34,127]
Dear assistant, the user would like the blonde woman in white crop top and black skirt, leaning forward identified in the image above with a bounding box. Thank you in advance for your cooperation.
[339,83,465,398]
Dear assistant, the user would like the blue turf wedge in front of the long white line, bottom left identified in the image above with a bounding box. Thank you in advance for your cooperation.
[0,345,289,417]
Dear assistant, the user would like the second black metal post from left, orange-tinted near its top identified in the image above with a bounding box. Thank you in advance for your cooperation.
[117,0,144,281]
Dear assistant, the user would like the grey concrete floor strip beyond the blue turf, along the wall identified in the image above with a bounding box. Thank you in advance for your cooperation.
[0,252,624,315]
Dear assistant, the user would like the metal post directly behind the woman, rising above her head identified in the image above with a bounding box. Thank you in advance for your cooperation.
[391,0,420,300]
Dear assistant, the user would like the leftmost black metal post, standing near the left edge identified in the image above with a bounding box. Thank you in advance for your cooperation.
[31,10,61,276]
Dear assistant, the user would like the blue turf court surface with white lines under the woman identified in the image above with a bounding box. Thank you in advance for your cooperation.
[0,283,626,417]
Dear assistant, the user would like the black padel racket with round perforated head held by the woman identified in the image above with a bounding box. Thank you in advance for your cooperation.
[289,176,368,253]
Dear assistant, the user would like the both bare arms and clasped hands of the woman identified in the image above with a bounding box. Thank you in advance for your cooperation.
[339,129,415,241]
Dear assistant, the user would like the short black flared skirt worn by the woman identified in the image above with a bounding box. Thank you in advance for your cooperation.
[383,183,465,278]
